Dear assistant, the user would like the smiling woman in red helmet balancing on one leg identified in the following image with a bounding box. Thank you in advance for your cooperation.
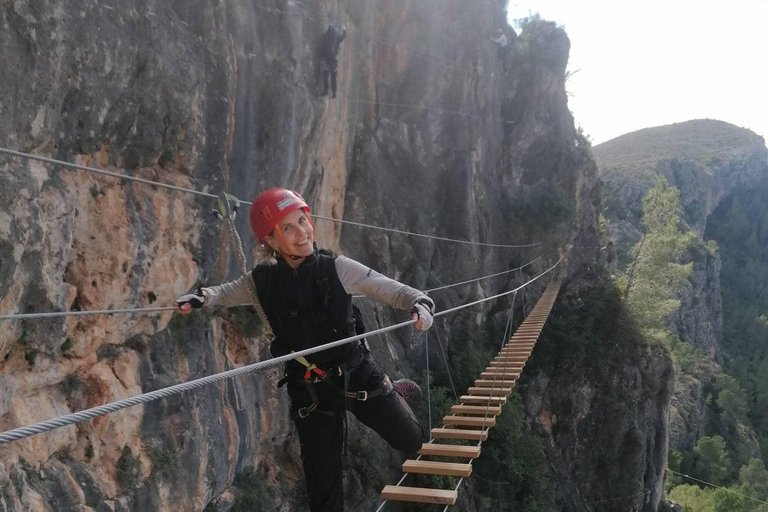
[176,188,434,512]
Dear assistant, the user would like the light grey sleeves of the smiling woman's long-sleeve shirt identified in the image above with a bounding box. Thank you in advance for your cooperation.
[203,256,425,309]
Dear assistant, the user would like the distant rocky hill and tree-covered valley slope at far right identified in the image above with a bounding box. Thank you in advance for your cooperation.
[595,121,768,512]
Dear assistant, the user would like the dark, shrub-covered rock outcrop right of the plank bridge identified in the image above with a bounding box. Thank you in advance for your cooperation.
[523,266,674,512]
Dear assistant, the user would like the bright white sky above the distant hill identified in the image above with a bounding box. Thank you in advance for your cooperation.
[508,0,768,144]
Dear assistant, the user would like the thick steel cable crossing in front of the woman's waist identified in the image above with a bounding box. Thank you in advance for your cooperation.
[0,256,564,446]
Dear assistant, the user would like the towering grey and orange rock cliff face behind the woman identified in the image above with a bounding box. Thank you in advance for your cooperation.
[0,0,667,512]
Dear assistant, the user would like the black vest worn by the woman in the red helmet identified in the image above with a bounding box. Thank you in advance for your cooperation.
[253,250,359,370]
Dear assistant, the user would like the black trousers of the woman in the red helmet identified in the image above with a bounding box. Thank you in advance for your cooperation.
[288,354,424,512]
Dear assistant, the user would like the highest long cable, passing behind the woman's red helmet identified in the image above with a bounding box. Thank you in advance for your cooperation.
[0,148,541,249]
